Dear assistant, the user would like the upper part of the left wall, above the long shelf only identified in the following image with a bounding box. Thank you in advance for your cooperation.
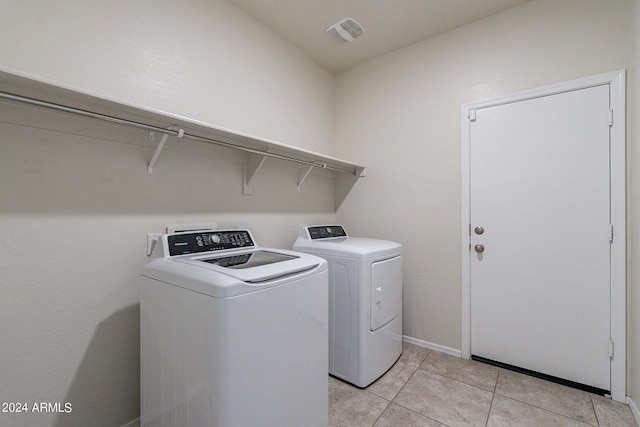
[0,0,333,152]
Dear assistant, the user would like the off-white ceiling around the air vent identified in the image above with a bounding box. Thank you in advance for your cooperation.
[229,0,528,73]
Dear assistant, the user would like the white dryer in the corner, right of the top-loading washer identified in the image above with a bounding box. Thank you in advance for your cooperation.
[293,225,402,387]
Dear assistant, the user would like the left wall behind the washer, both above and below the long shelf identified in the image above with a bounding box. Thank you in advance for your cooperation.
[0,0,335,426]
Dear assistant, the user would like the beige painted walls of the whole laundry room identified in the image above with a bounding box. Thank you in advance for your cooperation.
[0,0,640,426]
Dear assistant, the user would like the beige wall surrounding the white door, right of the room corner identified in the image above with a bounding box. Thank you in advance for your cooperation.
[336,0,640,393]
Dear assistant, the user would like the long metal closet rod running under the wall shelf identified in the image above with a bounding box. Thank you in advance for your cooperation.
[0,92,358,176]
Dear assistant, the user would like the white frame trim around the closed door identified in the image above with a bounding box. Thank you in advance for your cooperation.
[461,70,627,403]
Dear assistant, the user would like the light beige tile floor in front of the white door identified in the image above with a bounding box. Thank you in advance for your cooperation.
[329,343,638,427]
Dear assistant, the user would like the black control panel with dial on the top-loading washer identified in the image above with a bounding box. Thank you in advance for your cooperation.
[167,230,255,256]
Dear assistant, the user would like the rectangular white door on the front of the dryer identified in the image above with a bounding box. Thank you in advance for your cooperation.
[371,256,402,331]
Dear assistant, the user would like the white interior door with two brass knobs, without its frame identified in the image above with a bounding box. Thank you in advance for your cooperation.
[469,84,611,390]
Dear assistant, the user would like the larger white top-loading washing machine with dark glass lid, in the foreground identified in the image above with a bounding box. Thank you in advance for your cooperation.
[140,230,328,427]
